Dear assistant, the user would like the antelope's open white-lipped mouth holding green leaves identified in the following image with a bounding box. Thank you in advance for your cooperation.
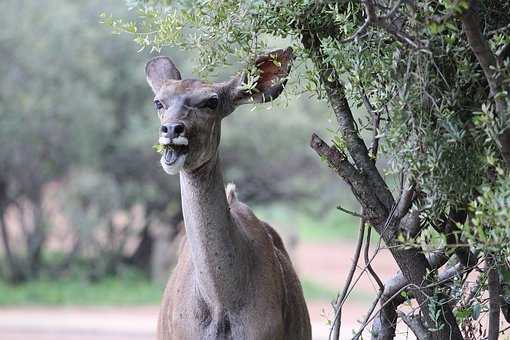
[159,137,189,175]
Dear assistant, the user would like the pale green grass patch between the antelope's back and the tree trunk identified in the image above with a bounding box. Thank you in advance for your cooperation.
[254,205,359,242]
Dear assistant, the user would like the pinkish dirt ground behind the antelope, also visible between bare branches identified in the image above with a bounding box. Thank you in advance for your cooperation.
[0,241,422,340]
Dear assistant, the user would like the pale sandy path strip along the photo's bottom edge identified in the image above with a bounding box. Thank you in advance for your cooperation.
[0,306,364,340]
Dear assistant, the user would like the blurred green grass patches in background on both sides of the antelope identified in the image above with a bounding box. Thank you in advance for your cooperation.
[0,204,368,306]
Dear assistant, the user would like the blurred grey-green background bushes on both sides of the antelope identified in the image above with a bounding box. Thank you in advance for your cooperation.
[0,0,356,286]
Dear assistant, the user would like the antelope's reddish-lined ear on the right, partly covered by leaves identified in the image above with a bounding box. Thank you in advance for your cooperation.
[232,47,294,106]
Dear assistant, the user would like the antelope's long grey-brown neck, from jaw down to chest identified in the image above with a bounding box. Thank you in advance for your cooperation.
[180,155,249,309]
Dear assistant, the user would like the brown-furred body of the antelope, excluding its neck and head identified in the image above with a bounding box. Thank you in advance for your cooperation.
[158,187,311,340]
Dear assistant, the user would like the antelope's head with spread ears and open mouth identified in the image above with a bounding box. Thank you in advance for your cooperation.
[145,48,294,175]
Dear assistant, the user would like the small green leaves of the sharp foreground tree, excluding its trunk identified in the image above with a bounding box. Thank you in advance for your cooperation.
[104,0,510,336]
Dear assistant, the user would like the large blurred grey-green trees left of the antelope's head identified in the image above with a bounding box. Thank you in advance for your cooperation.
[0,1,179,282]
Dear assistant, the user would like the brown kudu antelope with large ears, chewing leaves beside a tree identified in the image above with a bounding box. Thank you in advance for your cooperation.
[145,48,311,340]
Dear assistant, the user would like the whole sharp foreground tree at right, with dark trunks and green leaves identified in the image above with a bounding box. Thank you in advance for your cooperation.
[115,0,510,339]
